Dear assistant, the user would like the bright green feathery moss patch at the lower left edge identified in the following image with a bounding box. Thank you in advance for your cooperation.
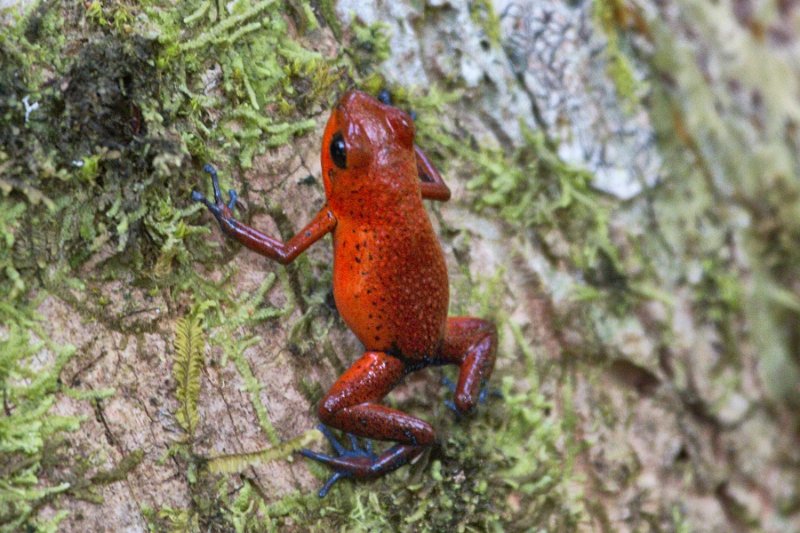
[0,286,143,531]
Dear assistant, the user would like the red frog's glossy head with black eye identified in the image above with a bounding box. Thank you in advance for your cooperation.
[322,90,417,206]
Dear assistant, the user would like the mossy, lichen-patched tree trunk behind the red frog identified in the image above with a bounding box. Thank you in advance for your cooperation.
[0,0,800,531]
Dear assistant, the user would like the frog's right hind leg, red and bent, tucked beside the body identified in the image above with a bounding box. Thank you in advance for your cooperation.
[439,317,497,414]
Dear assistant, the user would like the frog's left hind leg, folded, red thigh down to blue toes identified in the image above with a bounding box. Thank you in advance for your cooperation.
[302,352,435,497]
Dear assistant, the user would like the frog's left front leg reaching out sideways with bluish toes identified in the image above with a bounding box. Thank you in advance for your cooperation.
[192,165,336,265]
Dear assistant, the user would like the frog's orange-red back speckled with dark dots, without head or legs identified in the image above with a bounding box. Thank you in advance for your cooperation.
[333,197,449,359]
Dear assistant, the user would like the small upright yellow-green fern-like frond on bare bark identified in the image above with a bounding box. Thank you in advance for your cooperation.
[172,313,205,438]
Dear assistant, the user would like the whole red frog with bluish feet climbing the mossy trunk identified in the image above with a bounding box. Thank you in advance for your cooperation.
[192,90,497,497]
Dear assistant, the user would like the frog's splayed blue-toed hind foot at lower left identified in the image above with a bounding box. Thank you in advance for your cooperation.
[300,424,424,498]
